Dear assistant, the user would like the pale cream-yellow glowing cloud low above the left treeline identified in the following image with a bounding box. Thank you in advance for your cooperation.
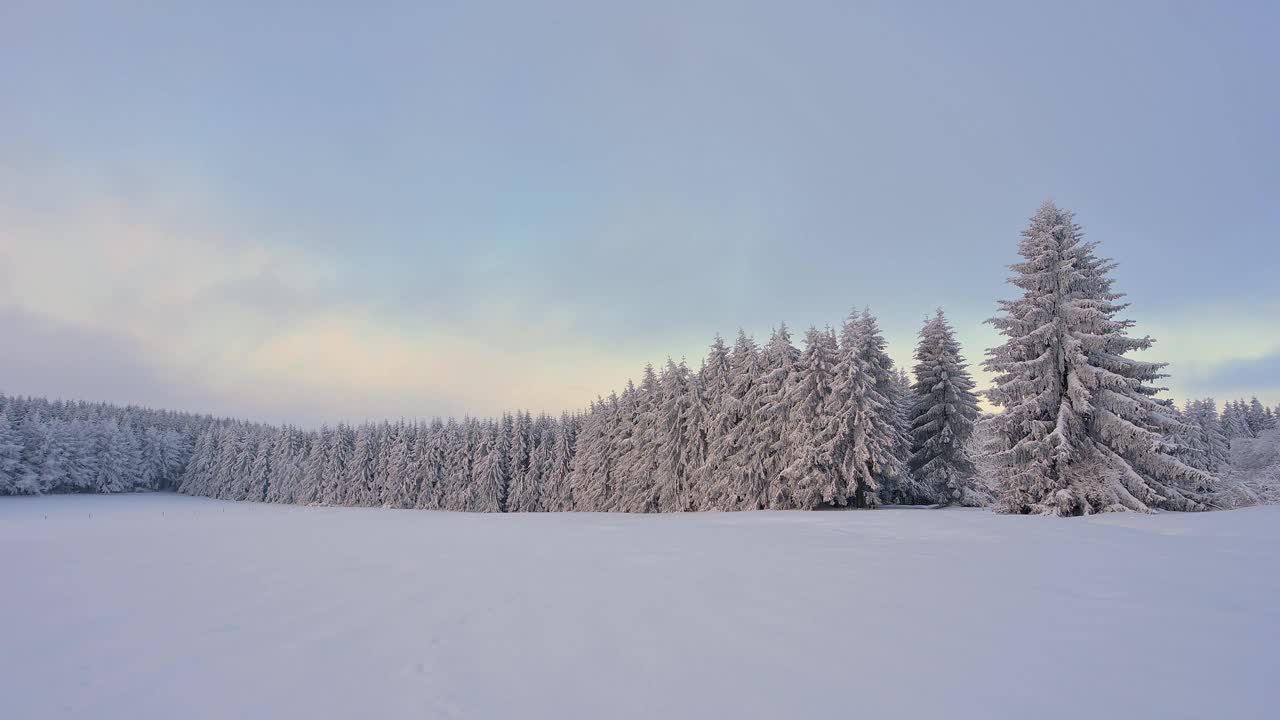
[0,193,659,424]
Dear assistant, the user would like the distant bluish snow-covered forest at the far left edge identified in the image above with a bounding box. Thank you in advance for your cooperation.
[0,395,215,495]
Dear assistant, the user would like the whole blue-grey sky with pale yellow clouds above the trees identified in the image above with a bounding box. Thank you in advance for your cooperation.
[0,0,1280,424]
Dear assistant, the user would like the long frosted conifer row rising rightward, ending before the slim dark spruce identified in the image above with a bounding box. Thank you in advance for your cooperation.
[179,311,973,512]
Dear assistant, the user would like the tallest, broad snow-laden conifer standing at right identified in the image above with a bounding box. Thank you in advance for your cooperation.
[986,202,1212,515]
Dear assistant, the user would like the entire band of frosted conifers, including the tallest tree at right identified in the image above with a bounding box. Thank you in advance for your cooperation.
[0,202,1280,515]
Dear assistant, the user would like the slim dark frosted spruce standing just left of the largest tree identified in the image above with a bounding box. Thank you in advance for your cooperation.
[909,309,979,505]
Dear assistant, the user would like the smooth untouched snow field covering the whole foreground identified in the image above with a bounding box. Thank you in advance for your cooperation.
[0,495,1280,720]
